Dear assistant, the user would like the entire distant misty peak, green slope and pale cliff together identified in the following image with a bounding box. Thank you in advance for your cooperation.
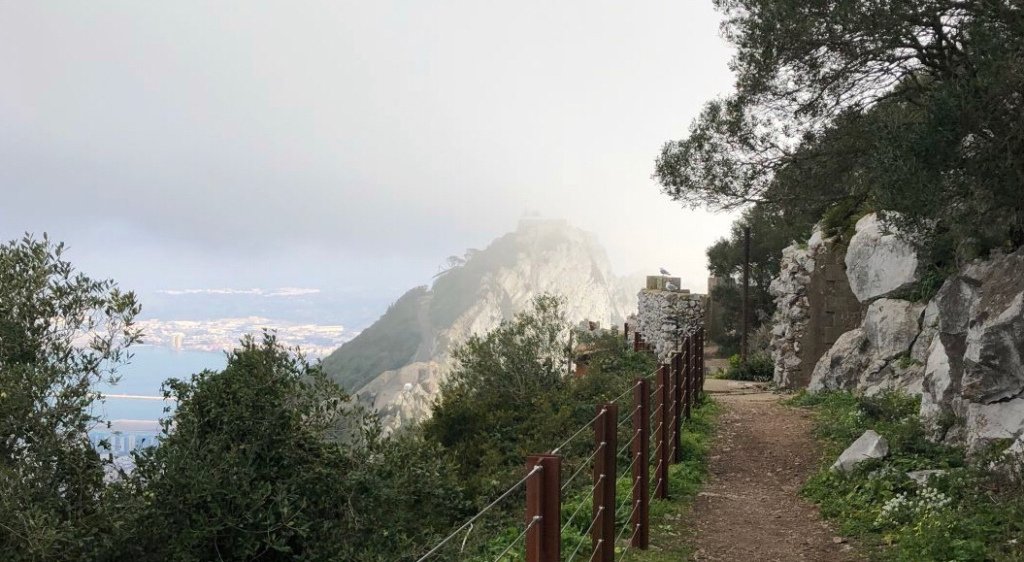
[325,220,636,429]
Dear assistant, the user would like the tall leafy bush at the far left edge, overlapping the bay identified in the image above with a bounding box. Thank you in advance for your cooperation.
[0,235,140,560]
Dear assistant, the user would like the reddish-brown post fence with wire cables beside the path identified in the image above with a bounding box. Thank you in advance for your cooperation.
[418,328,705,562]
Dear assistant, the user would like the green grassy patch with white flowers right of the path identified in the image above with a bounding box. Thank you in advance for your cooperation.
[790,386,1024,562]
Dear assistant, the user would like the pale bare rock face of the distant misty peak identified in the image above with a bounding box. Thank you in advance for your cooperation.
[335,220,638,431]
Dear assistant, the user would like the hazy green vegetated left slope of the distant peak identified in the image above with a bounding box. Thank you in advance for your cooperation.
[324,287,427,392]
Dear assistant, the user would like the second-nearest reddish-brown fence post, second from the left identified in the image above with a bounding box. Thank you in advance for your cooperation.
[590,404,618,562]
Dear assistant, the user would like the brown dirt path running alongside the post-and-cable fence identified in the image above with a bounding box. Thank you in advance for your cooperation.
[691,380,859,561]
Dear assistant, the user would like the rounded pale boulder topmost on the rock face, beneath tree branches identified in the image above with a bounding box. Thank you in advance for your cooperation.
[846,213,919,302]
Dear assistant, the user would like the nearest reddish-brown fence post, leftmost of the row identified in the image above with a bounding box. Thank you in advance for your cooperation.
[526,455,562,562]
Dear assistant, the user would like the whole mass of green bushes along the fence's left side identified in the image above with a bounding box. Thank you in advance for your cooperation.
[0,239,713,561]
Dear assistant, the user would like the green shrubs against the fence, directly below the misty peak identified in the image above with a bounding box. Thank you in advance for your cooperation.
[423,296,653,496]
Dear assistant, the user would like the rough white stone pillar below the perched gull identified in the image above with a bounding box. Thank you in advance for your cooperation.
[637,289,705,362]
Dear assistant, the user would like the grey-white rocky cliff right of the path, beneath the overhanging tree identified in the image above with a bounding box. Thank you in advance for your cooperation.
[776,215,1024,450]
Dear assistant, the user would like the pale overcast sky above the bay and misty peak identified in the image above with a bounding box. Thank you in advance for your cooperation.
[0,0,732,304]
